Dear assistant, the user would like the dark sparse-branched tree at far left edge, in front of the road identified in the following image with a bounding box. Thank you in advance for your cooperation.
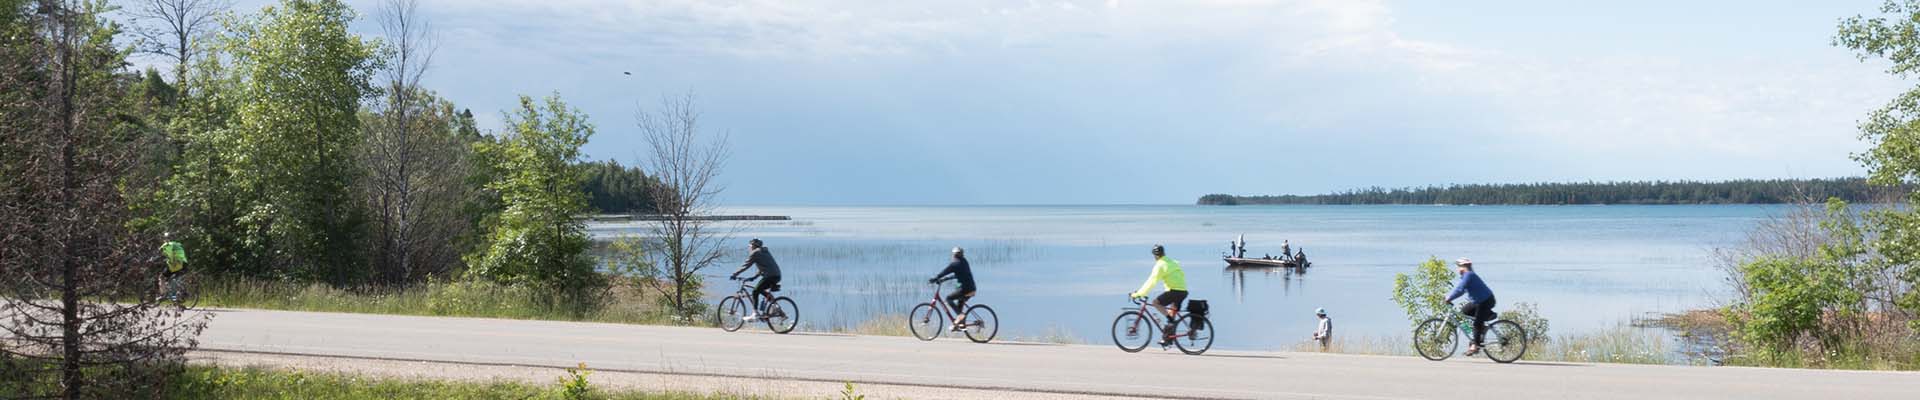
[0,0,205,398]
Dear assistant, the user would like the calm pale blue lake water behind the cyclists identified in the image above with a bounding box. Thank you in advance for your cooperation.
[593,206,1784,350]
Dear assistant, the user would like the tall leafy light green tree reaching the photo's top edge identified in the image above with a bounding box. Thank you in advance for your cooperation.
[223,0,382,285]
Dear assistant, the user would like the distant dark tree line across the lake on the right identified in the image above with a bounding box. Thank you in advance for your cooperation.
[1198,177,1908,206]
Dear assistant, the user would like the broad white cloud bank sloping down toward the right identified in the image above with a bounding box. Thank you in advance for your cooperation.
[374,0,1903,189]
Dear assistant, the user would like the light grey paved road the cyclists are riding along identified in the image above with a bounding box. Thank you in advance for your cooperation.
[202,310,1920,400]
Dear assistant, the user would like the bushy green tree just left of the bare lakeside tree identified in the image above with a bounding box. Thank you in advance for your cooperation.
[467,94,605,300]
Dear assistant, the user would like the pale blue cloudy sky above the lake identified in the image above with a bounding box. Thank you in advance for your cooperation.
[161,0,1912,204]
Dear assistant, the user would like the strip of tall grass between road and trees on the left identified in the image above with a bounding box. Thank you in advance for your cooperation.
[198,279,683,323]
